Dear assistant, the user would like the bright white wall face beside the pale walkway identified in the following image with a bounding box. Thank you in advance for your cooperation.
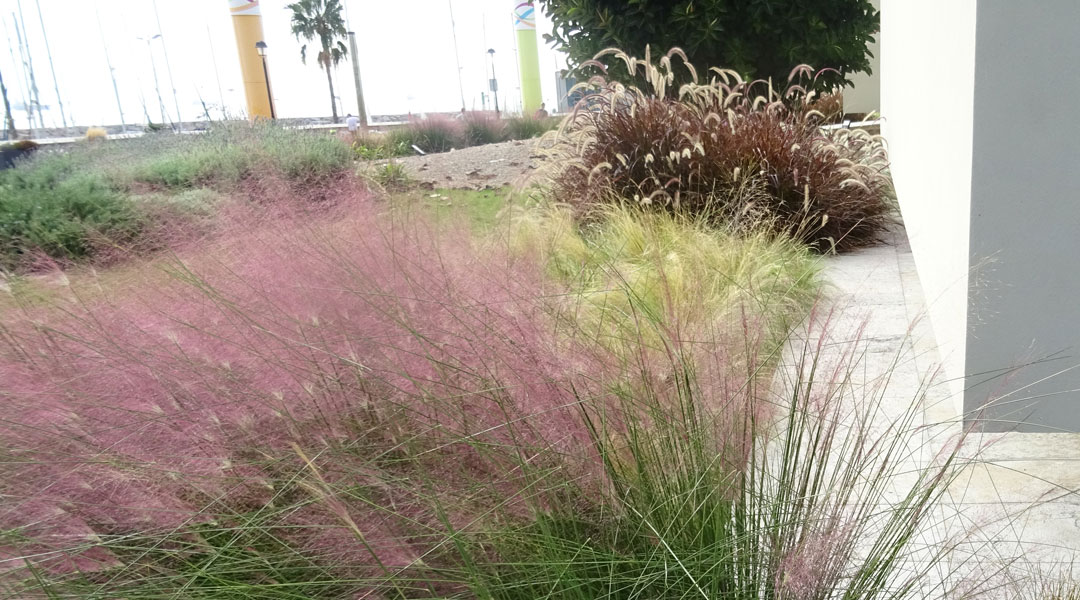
[880,0,975,399]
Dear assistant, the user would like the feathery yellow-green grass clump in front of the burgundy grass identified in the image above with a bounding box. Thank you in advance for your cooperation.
[507,206,822,351]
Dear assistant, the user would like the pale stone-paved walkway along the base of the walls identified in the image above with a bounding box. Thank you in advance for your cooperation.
[812,223,1080,598]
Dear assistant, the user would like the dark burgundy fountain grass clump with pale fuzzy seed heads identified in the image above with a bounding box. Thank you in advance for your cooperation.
[552,49,893,251]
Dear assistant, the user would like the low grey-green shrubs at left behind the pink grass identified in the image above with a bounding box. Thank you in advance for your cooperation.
[0,123,353,269]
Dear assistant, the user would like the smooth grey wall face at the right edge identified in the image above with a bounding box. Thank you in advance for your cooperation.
[976,0,1080,432]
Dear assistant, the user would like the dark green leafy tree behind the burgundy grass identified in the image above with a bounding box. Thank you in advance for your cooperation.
[542,0,879,90]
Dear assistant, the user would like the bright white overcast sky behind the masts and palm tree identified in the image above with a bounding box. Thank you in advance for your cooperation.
[0,0,565,128]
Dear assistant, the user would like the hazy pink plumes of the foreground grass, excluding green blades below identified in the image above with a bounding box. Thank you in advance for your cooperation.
[0,202,603,582]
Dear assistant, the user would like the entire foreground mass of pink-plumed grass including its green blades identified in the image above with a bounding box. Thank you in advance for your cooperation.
[0,196,980,599]
